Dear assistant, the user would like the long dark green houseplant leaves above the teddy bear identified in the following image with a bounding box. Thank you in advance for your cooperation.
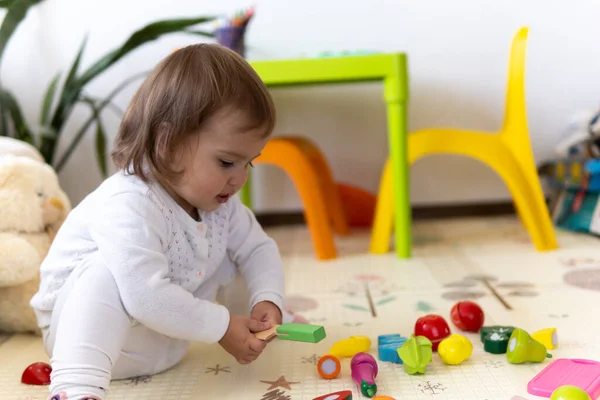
[0,0,216,175]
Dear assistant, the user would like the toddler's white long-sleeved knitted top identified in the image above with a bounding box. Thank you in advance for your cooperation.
[31,173,284,343]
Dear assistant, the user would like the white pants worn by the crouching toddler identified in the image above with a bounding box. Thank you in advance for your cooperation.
[43,257,249,399]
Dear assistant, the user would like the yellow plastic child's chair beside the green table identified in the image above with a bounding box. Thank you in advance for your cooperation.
[370,27,558,254]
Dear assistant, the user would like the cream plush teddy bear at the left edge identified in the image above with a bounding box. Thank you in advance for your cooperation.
[0,146,71,334]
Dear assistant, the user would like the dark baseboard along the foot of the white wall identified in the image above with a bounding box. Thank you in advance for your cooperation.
[256,201,515,227]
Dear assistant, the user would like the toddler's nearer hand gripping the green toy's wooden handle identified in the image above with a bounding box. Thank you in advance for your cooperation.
[219,315,271,364]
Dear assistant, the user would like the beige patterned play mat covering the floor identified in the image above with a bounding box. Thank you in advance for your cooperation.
[0,218,600,400]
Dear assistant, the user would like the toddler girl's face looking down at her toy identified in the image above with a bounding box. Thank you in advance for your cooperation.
[165,109,268,216]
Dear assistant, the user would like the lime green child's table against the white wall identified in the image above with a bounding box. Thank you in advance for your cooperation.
[240,53,411,258]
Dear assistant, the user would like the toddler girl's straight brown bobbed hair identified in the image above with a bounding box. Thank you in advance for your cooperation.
[112,43,275,181]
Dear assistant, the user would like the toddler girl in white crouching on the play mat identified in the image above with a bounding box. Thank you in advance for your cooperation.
[31,44,284,399]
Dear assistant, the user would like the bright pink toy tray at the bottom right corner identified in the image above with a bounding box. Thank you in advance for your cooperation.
[527,358,600,399]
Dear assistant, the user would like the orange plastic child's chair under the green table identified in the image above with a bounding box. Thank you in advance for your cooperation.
[251,136,349,260]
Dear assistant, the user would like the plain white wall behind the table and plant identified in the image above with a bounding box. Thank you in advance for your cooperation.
[1,0,600,210]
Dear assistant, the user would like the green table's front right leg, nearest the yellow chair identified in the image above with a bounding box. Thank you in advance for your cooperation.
[386,92,412,258]
